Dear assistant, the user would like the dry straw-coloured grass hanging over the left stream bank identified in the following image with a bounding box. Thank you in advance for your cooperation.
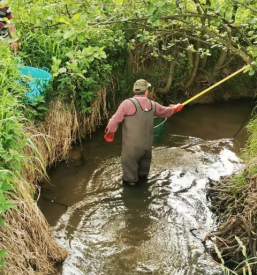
[0,87,108,275]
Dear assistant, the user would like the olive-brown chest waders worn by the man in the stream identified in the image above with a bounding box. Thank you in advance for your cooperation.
[121,98,155,182]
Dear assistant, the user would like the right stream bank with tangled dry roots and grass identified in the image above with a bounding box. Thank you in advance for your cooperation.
[206,109,257,274]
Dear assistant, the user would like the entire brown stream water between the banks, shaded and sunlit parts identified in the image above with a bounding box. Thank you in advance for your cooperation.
[39,101,252,275]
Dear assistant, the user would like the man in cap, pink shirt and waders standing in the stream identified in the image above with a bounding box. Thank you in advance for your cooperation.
[104,79,183,185]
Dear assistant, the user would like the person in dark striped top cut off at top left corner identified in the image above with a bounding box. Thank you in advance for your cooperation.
[0,3,18,52]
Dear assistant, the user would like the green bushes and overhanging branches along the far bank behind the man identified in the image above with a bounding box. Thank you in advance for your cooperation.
[10,0,257,104]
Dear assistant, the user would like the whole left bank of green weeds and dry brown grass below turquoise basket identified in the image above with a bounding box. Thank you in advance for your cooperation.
[0,43,107,274]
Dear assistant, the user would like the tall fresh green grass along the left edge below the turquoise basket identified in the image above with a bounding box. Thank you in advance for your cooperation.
[0,44,43,270]
